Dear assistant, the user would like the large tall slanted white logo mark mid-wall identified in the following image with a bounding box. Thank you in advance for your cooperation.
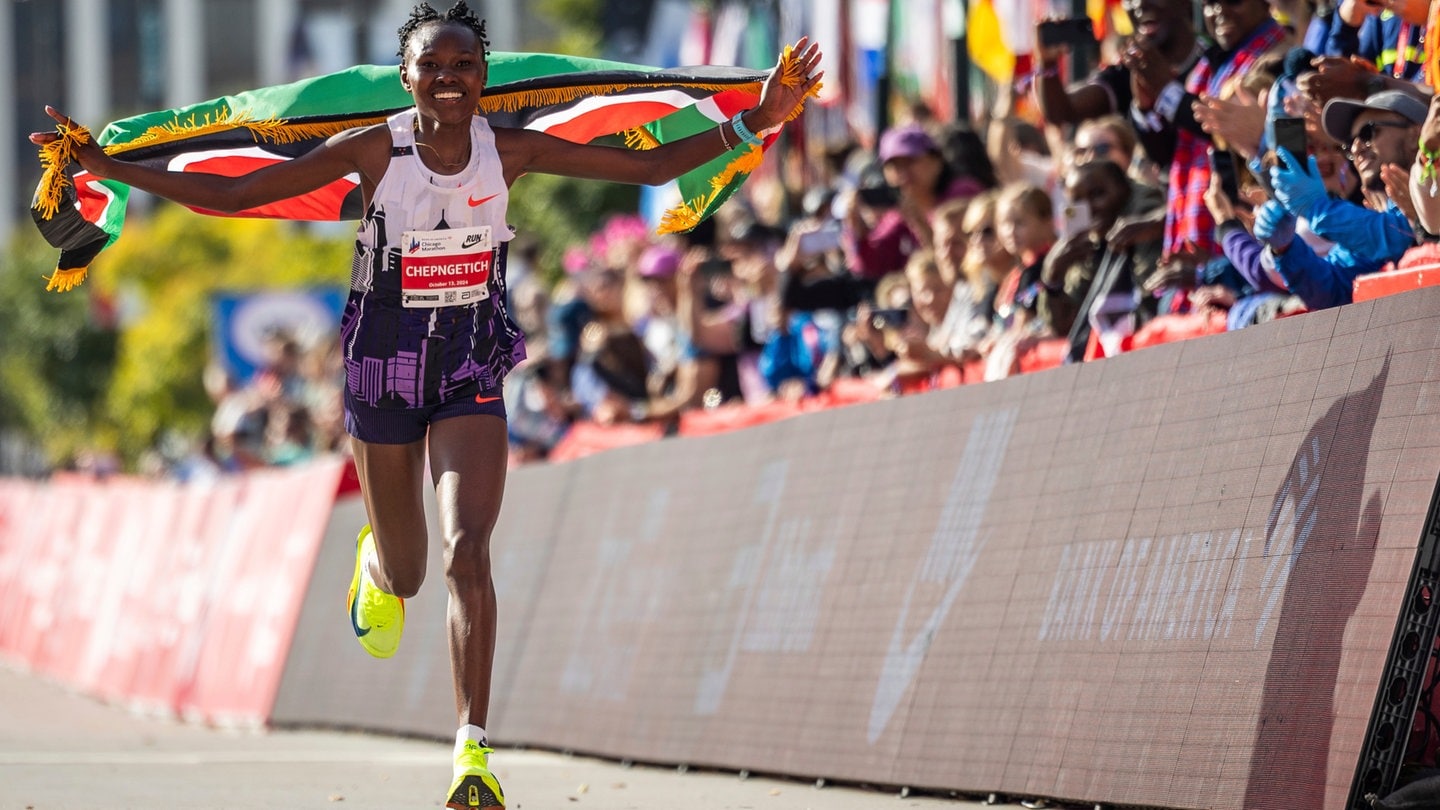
[868,409,1017,742]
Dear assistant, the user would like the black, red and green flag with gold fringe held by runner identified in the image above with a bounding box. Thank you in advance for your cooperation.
[30,48,818,291]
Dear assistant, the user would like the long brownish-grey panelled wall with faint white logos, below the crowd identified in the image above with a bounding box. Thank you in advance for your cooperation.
[276,290,1440,810]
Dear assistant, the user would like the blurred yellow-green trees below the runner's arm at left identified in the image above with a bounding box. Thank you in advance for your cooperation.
[0,205,353,466]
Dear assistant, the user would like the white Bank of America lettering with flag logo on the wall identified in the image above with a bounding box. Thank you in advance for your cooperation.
[1037,438,1320,644]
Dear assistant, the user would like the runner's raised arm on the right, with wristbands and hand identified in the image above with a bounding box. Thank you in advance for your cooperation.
[495,37,825,186]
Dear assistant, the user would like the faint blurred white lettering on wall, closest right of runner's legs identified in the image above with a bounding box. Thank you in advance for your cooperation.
[560,490,674,702]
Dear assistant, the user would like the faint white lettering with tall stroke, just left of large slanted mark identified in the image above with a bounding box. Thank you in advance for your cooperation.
[694,460,847,715]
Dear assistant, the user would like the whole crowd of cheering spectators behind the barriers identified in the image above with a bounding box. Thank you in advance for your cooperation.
[135,0,1440,468]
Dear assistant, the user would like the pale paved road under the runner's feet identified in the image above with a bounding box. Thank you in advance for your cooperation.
[0,666,1018,810]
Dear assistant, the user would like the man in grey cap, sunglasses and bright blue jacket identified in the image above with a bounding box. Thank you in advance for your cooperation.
[1254,91,1426,310]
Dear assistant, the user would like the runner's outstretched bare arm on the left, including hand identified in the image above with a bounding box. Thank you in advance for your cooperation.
[30,107,390,213]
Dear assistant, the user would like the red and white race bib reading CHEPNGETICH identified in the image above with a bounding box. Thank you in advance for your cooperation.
[400,225,495,307]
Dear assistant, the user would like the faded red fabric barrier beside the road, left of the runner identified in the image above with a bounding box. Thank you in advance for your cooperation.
[0,460,341,725]
